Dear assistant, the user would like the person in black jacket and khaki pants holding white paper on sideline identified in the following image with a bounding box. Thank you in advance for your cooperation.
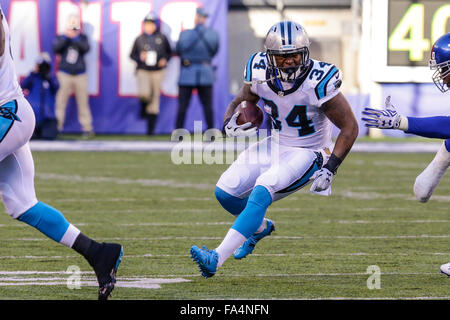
[130,12,172,135]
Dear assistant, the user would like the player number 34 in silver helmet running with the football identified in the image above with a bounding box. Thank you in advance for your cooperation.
[190,21,358,278]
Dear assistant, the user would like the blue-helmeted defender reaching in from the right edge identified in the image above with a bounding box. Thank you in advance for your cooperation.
[362,33,450,276]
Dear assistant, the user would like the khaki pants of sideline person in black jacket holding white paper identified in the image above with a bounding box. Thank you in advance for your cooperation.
[136,69,164,114]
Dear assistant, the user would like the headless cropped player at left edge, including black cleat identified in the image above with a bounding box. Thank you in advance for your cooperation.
[0,7,123,300]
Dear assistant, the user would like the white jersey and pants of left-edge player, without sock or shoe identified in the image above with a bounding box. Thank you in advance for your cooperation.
[0,8,38,218]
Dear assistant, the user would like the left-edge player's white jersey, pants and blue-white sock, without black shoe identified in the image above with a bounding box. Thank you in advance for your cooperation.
[0,7,80,247]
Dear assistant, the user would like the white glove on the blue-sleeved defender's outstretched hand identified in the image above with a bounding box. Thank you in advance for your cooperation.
[361,96,402,129]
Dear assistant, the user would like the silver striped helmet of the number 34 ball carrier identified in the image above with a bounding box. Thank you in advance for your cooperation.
[264,21,310,82]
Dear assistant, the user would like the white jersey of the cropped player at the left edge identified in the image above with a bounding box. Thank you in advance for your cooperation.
[0,7,23,106]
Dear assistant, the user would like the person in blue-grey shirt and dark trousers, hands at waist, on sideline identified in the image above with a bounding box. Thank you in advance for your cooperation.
[175,8,219,129]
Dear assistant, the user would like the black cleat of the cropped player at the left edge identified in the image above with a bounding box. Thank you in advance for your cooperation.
[93,242,123,300]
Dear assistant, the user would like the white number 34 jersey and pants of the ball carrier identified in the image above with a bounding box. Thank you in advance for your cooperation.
[217,52,342,201]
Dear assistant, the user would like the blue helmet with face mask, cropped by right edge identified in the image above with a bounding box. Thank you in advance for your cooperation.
[430,33,450,92]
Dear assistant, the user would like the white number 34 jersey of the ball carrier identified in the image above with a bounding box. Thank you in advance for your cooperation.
[244,52,342,149]
